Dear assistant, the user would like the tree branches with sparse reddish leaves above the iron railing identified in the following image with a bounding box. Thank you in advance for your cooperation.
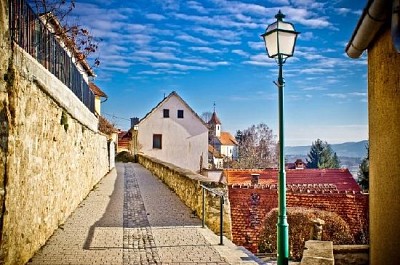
[29,0,100,67]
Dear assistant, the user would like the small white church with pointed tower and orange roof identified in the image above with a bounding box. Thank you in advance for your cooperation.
[208,111,238,168]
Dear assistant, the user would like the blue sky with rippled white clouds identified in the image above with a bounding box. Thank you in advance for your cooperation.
[74,0,368,145]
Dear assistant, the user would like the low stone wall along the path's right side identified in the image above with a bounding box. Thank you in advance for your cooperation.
[137,154,232,239]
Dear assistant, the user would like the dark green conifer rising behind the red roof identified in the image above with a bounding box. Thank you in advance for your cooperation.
[307,139,340,168]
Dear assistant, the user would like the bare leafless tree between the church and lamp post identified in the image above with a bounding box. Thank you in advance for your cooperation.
[235,123,277,168]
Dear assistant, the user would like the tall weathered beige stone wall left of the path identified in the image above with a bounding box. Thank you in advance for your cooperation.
[0,4,109,265]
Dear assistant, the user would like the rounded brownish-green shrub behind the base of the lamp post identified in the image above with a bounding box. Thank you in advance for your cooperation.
[258,207,354,260]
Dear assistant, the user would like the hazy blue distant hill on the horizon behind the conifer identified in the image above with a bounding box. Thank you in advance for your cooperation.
[285,140,368,158]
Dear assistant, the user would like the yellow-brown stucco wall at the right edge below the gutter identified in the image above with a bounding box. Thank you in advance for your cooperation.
[368,29,400,264]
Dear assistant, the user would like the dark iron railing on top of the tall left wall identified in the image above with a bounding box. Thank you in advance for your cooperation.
[9,0,94,113]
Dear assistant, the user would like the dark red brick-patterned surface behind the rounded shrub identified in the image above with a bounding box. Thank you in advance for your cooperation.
[229,186,368,253]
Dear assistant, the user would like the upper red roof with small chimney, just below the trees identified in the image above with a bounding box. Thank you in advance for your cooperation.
[223,169,361,192]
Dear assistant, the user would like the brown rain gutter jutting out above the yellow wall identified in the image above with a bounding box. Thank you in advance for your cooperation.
[346,0,392,58]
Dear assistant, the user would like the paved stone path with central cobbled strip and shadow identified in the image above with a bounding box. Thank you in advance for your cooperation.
[28,163,261,265]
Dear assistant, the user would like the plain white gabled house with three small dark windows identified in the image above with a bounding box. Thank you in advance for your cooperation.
[134,92,208,172]
